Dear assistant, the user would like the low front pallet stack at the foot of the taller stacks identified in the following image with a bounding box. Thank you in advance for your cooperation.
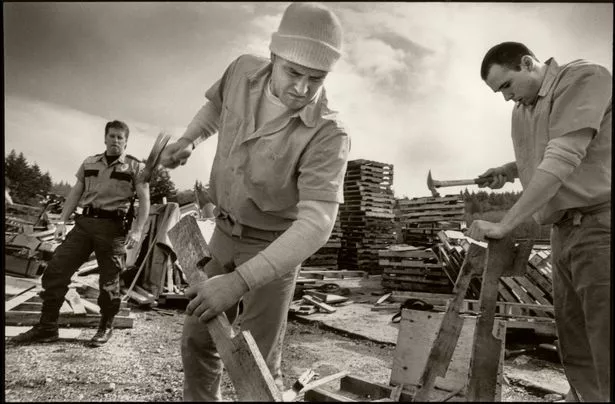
[378,247,455,293]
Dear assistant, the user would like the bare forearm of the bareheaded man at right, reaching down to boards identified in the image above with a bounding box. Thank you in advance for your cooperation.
[500,169,562,231]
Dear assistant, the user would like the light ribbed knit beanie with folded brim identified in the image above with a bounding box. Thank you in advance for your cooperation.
[269,2,342,72]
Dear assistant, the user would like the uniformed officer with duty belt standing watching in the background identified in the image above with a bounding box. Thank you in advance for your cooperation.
[12,121,150,345]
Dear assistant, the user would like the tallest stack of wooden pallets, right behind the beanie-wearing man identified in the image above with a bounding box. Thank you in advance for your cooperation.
[338,160,395,273]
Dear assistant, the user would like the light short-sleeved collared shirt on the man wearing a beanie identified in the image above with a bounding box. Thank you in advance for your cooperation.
[205,55,350,231]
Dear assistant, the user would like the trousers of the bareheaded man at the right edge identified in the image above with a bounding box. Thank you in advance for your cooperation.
[551,210,612,402]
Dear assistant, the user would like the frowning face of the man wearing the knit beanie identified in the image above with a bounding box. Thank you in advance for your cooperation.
[271,55,328,110]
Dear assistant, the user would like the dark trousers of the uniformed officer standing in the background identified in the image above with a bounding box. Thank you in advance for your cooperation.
[40,216,126,327]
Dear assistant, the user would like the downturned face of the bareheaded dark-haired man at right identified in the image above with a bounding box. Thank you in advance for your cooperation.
[485,63,541,105]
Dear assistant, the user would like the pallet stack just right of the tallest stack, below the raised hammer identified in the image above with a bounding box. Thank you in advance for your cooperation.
[396,195,465,247]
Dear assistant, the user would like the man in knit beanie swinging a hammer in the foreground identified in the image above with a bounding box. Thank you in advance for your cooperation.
[161,3,350,401]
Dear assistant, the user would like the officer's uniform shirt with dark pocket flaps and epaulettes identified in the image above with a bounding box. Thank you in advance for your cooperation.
[75,153,145,211]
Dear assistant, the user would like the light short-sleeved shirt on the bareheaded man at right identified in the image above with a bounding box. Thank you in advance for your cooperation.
[512,59,612,224]
